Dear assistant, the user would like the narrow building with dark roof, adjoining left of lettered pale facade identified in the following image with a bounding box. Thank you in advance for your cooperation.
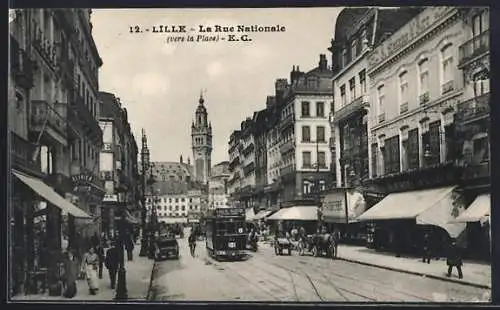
[329,8,421,187]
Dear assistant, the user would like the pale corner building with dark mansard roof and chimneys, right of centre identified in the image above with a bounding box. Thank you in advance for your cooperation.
[279,55,333,202]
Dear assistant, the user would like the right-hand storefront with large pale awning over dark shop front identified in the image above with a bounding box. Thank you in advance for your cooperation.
[358,186,466,254]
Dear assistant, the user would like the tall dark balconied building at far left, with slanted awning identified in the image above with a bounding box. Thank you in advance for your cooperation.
[8,9,104,294]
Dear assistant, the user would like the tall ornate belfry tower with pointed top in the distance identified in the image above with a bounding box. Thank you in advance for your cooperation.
[191,94,212,184]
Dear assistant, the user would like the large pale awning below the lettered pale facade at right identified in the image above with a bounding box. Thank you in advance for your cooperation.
[358,186,465,238]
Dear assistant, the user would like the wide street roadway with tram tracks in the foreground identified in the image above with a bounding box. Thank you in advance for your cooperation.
[150,239,489,302]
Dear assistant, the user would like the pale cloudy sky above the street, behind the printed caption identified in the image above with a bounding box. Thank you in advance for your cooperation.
[91,8,341,164]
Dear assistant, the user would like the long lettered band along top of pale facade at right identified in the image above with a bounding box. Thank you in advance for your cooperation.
[368,7,454,69]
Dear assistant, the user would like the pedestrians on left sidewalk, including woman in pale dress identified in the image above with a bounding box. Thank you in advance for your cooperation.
[63,234,138,298]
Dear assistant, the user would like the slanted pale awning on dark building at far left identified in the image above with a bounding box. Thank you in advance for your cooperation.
[13,171,92,218]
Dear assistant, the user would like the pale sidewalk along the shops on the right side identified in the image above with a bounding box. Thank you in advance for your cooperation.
[338,245,491,289]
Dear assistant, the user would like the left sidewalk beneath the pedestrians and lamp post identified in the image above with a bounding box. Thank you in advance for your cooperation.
[12,244,154,302]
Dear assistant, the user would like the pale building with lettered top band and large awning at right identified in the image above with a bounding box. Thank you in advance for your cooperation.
[359,7,484,251]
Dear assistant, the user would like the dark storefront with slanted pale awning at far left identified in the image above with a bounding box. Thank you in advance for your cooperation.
[11,170,90,294]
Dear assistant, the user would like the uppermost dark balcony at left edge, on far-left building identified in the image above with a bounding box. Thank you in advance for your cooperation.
[10,36,34,88]
